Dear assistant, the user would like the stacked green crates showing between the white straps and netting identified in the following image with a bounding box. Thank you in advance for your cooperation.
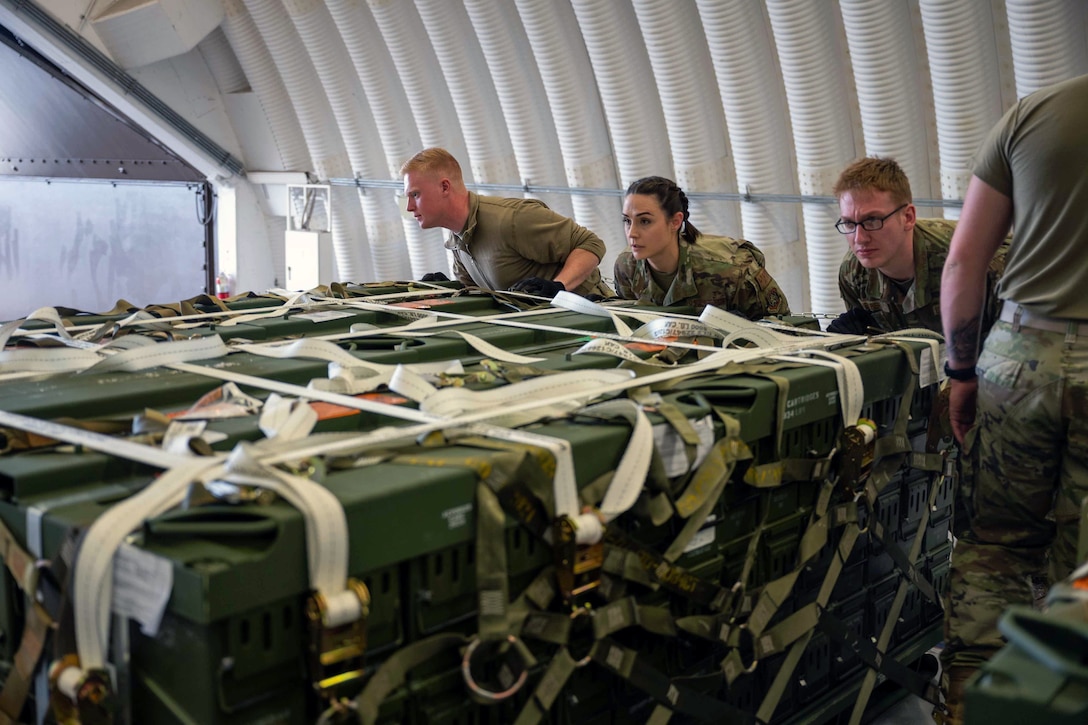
[0,285,953,725]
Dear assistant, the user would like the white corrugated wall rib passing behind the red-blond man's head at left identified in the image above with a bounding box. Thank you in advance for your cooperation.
[368,0,472,277]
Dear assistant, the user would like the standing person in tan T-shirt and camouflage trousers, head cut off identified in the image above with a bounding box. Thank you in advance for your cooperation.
[941,75,1088,722]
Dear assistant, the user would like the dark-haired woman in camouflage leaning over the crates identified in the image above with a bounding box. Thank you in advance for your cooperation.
[615,176,790,320]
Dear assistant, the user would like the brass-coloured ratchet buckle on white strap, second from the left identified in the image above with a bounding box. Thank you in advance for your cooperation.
[306,579,370,696]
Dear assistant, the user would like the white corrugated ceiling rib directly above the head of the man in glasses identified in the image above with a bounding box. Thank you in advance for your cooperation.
[839,0,930,200]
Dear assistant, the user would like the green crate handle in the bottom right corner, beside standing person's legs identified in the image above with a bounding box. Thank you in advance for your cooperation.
[998,606,1088,683]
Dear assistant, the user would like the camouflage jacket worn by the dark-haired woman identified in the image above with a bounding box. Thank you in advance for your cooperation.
[615,235,790,320]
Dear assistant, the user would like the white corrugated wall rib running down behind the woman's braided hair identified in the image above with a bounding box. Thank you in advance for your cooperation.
[632,0,741,236]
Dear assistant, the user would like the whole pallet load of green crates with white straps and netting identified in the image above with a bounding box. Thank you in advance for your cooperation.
[0,284,954,724]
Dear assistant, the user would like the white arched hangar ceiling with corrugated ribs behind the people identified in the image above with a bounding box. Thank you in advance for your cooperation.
[0,0,1088,311]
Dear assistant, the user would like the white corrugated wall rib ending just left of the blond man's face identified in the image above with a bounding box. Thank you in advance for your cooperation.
[285,2,400,281]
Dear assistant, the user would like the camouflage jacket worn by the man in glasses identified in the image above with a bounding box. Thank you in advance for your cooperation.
[839,219,1009,335]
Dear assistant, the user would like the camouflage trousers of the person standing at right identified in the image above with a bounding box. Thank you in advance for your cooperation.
[941,321,1088,667]
